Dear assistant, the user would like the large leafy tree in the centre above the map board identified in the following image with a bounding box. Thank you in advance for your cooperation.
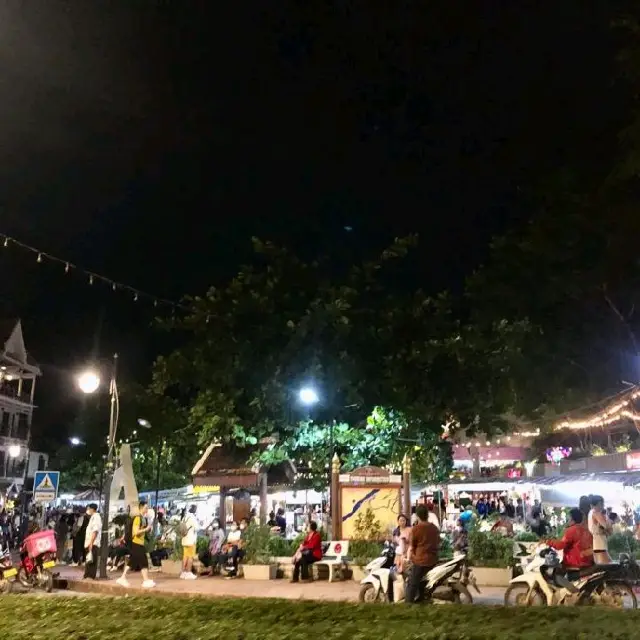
[152,237,527,473]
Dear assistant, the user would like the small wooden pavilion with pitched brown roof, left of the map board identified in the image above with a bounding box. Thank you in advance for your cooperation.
[192,440,296,522]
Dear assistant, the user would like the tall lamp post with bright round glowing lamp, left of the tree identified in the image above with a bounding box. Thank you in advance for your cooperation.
[78,353,120,580]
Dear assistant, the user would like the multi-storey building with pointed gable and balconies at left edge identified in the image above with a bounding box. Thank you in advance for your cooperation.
[0,320,47,493]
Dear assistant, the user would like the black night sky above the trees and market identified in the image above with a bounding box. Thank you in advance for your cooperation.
[0,0,627,444]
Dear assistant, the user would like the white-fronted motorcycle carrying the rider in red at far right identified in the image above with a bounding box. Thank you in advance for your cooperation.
[504,545,638,609]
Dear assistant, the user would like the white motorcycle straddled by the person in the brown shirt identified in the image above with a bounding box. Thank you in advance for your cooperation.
[359,545,480,604]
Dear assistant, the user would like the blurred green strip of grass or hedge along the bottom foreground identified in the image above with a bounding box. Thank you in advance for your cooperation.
[0,595,640,640]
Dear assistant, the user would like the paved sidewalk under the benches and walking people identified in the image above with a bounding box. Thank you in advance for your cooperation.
[56,566,504,604]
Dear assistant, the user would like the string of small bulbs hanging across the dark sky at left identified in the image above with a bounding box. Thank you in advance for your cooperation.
[0,233,184,310]
